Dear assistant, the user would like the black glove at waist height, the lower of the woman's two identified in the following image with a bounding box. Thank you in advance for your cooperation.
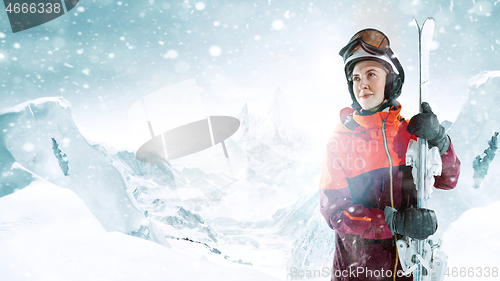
[384,206,437,240]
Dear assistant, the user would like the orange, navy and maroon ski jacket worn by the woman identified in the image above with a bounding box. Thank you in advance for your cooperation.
[320,103,460,280]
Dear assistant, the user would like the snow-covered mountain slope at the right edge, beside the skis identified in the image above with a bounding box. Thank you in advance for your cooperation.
[429,71,500,236]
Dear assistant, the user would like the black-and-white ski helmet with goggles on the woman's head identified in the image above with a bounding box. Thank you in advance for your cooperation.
[339,28,405,112]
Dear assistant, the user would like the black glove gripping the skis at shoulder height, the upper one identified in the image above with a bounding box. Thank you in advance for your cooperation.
[406,102,450,155]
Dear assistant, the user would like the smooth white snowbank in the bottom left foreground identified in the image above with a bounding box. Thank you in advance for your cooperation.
[0,179,282,281]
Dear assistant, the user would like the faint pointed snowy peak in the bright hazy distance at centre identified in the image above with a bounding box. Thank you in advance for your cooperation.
[234,88,319,195]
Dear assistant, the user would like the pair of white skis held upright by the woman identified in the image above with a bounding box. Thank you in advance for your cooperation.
[396,18,448,281]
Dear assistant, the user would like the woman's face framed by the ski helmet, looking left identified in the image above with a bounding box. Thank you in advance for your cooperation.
[352,60,387,111]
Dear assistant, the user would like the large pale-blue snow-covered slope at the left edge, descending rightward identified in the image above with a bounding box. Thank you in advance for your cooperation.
[0,98,145,233]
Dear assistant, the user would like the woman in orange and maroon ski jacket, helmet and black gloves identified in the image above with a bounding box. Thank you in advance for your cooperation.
[320,29,460,280]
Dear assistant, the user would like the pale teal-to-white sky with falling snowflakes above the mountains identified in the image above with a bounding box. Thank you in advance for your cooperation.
[0,0,500,149]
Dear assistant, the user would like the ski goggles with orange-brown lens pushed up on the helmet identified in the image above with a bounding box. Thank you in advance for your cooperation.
[339,28,390,62]
